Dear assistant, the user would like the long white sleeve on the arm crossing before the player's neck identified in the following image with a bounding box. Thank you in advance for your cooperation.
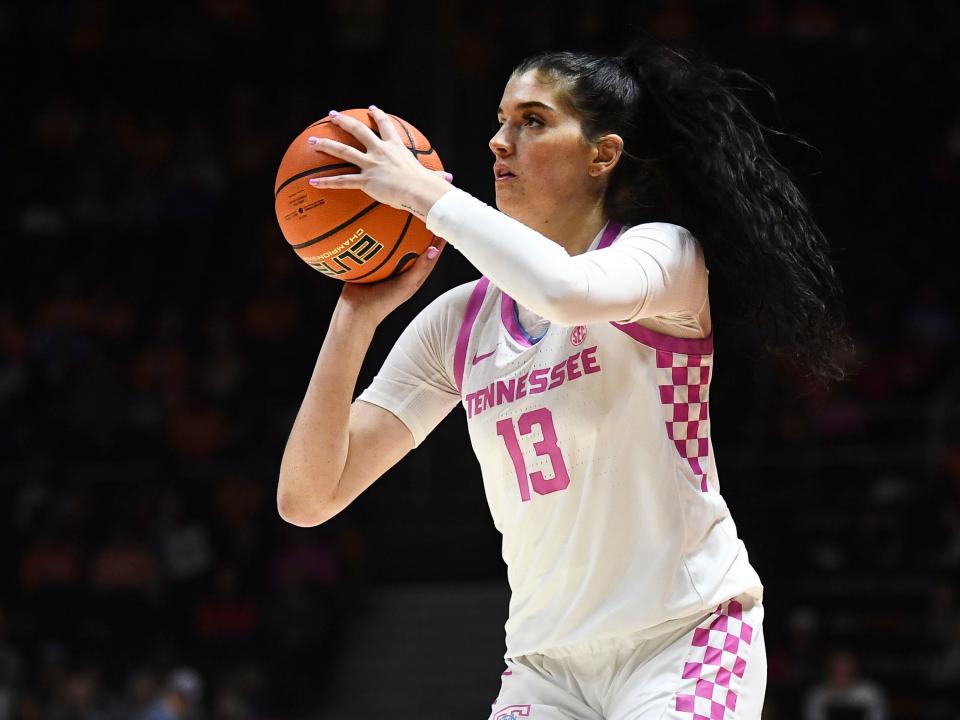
[427,189,707,325]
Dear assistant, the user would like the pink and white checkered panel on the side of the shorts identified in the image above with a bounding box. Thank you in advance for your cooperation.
[676,600,753,720]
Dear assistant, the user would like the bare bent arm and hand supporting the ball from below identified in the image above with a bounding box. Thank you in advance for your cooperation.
[277,239,442,527]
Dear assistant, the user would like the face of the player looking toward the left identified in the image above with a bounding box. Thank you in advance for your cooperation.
[490,71,600,227]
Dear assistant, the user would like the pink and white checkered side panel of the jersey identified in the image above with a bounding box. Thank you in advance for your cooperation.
[657,350,713,492]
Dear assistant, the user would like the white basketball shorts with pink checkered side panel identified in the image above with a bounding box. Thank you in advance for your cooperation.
[489,596,767,720]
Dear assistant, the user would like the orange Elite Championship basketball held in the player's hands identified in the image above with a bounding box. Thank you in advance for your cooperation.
[274,110,443,283]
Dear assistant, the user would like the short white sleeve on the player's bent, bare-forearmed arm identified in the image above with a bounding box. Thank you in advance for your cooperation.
[357,283,474,447]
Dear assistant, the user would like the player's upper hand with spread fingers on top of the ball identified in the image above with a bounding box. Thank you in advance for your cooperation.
[307,105,453,219]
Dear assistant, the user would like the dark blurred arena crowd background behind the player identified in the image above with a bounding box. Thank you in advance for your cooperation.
[0,0,960,720]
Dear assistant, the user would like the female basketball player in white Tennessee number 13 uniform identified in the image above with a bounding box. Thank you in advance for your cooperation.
[278,40,844,720]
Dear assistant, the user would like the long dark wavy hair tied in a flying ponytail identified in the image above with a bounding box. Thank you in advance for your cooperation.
[513,41,849,379]
